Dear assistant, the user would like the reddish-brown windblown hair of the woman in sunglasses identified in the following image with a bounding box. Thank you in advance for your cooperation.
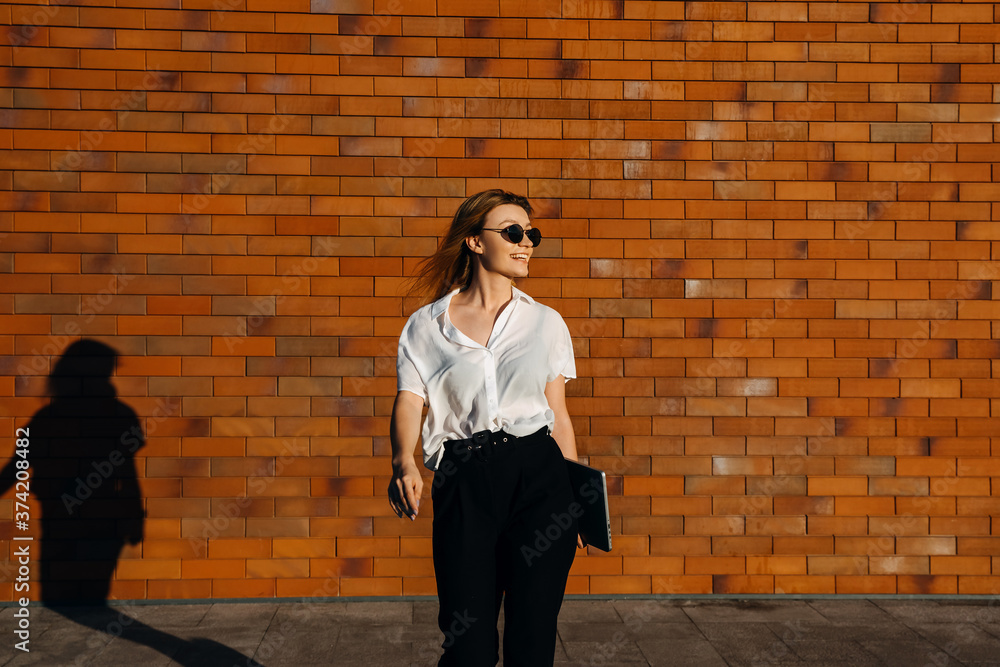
[410,189,532,300]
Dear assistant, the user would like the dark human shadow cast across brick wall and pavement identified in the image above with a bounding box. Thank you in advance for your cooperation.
[0,339,266,666]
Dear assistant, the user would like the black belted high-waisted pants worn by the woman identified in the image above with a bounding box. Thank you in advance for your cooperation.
[431,429,577,667]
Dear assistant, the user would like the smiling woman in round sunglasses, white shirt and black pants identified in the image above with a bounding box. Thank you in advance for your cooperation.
[389,190,582,667]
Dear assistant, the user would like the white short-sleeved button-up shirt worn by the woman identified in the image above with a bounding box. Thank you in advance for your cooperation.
[396,287,576,470]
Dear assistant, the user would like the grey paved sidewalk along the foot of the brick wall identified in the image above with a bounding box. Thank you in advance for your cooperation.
[0,598,1000,667]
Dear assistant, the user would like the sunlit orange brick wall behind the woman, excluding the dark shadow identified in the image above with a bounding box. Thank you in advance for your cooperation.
[0,0,1000,599]
